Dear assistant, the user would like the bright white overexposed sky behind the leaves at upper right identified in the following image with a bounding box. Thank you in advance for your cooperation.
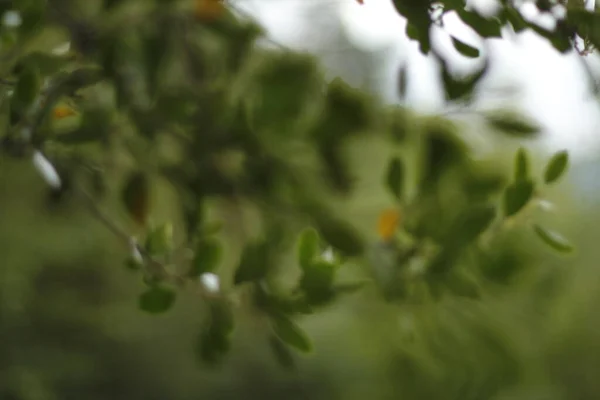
[238,0,600,157]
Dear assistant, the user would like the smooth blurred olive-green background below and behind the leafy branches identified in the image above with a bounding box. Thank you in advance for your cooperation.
[0,0,600,400]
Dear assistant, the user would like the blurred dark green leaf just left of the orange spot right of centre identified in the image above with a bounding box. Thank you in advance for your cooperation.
[315,215,364,257]
